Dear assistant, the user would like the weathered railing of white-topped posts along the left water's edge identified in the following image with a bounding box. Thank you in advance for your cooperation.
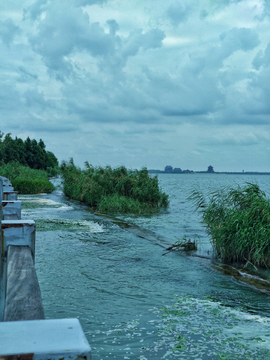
[0,177,91,360]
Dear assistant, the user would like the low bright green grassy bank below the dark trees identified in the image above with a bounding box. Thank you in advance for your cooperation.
[0,162,54,194]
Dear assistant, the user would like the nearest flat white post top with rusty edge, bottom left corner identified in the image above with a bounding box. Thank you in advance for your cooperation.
[0,319,91,360]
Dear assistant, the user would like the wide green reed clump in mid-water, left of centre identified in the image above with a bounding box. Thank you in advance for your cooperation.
[61,159,169,214]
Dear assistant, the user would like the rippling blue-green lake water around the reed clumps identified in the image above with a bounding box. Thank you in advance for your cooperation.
[20,174,270,360]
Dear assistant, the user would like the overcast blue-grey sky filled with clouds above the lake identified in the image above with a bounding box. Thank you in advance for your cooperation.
[0,0,270,171]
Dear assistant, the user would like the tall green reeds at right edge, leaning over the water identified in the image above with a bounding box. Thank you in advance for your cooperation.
[190,183,270,267]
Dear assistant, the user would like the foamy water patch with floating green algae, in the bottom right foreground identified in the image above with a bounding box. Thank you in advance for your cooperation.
[93,296,270,360]
